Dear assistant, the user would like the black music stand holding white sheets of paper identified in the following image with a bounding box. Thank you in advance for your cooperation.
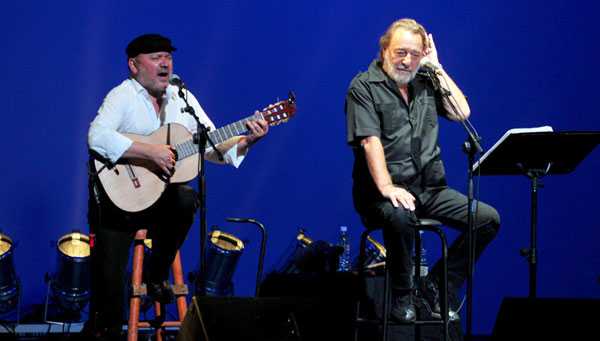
[473,127,600,298]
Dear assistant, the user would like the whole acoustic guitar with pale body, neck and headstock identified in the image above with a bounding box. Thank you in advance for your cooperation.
[93,93,296,212]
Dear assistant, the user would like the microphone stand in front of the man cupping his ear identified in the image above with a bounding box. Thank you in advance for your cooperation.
[425,68,483,341]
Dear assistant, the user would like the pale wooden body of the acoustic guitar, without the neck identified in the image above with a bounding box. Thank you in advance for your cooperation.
[94,123,199,212]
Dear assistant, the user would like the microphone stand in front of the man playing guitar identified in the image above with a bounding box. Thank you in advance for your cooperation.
[178,85,223,296]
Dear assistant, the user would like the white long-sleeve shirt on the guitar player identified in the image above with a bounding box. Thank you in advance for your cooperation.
[88,78,245,167]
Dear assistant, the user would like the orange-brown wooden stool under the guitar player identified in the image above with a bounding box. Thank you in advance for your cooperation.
[127,229,188,341]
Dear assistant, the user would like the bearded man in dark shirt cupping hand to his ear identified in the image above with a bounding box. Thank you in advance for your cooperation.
[346,19,500,322]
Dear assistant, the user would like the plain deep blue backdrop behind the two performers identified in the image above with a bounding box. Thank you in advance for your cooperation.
[0,0,600,334]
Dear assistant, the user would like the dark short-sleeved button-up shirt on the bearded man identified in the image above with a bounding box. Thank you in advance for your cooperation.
[346,60,446,199]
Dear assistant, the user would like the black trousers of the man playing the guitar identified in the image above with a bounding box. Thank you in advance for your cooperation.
[88,185,199,333]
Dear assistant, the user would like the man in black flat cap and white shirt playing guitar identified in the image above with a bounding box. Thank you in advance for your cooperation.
[83,34,268,340]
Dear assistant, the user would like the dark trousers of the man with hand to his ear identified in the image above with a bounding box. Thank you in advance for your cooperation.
[355,186,500,308]
